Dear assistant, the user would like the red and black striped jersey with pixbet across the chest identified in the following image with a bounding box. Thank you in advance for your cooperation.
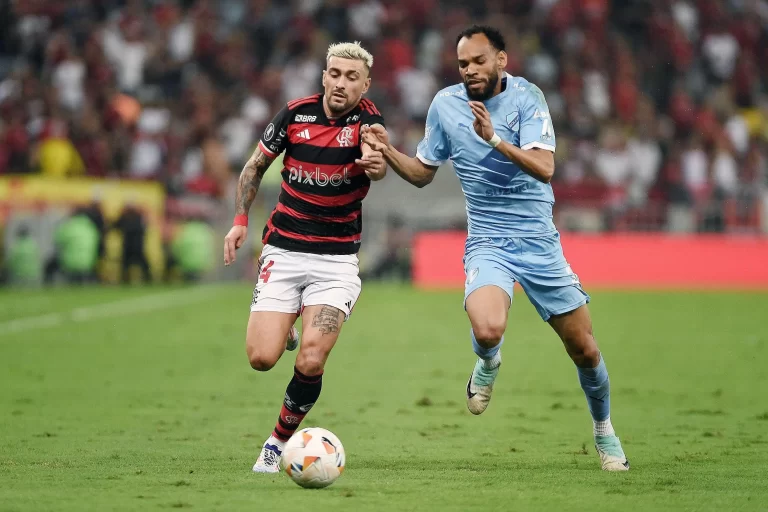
[259,94,384,254]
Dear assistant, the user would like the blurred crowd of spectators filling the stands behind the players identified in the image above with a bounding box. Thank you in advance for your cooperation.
[0,0,768,286]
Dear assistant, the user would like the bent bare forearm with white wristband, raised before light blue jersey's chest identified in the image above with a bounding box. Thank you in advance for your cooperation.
[469,101,555,183]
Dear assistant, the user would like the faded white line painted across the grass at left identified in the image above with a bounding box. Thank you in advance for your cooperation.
[0,286,226,336]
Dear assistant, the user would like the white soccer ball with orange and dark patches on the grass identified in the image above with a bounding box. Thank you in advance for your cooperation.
[280,427,346,489]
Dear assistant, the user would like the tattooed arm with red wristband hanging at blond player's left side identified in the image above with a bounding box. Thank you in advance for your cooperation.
[224,107,291,265]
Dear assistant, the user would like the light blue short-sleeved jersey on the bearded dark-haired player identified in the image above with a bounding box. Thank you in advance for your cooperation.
[416,74,555,237]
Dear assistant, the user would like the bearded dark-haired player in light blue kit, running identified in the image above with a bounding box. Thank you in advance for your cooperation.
[363,26,629,471]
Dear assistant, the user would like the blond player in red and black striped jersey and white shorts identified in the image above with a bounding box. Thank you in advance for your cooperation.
[224,43,387,473]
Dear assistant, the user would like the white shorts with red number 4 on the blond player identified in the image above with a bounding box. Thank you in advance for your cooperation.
[251,244,362,318]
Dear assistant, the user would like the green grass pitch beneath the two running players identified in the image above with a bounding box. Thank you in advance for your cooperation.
[0,284,768,512]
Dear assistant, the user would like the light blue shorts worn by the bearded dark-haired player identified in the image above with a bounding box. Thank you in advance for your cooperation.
[464,233,589,321]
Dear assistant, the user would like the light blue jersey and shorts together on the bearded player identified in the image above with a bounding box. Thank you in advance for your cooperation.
[416,74,589,320]
